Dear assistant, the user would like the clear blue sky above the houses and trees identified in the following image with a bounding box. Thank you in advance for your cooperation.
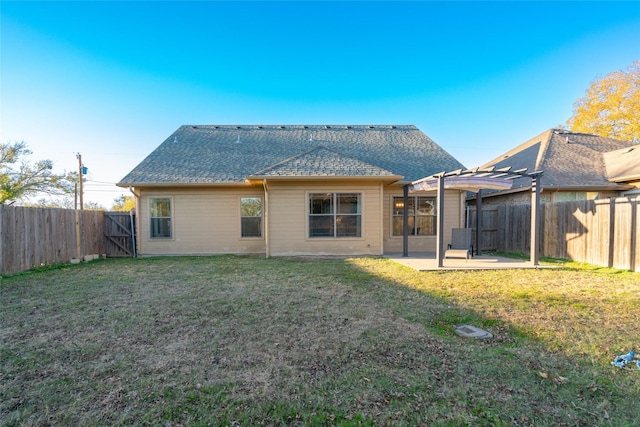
[0,0,640,207]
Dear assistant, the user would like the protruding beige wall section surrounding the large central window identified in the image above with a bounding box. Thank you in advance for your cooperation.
[268,181,382,256]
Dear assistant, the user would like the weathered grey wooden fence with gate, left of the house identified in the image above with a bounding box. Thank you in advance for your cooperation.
[0,204,104,274]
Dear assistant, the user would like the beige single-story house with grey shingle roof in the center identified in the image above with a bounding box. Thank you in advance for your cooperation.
[118,125,464,256]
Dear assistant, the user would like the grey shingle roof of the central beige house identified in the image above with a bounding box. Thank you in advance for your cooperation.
[118,125,463,186]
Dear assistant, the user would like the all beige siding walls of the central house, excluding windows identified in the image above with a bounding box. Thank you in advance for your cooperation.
[136,181,464,256]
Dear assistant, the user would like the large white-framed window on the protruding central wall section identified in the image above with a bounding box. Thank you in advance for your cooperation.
[309,193,362,237]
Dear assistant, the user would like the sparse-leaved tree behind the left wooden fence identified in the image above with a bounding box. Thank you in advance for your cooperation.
[0,141,73,204]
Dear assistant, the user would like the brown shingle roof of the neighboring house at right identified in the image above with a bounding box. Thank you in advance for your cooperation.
[482,129,637,191]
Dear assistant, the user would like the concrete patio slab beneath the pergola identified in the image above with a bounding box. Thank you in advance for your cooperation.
[383,252,555,271]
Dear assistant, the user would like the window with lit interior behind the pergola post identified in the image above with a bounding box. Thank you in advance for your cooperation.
[393,196,437,236]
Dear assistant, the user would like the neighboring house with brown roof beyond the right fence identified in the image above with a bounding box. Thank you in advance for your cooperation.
[469,129,640,204]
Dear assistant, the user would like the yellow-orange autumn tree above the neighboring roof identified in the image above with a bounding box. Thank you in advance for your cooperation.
[567,61,640,142]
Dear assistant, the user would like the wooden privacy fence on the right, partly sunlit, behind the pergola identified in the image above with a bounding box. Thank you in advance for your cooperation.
[469,197,640,271]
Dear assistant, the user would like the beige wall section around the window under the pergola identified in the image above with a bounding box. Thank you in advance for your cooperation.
[383,187,464,253]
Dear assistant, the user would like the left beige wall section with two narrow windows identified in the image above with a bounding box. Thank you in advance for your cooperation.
[138,186,265,255]
